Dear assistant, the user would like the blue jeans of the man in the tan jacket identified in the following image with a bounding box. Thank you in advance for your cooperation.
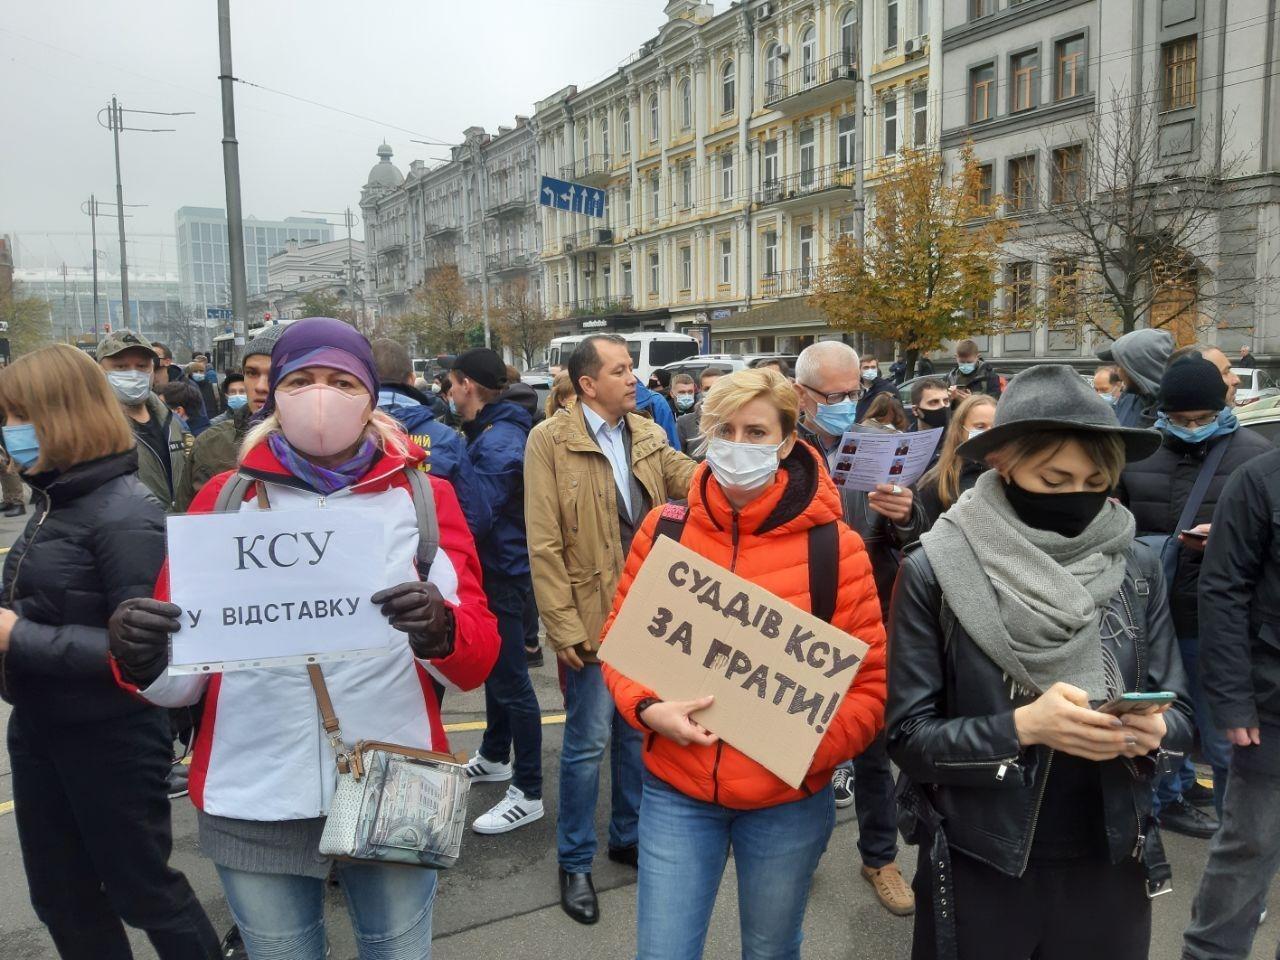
[556,663,644,873]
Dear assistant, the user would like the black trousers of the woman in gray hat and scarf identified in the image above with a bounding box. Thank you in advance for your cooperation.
[911,850,1151,960]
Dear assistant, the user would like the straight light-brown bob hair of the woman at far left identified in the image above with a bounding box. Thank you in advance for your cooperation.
[0,343,133,472]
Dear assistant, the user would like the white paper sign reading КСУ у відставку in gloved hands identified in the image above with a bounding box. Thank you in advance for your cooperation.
[168,507,394,675]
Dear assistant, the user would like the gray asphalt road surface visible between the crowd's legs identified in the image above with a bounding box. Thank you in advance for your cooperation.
[0,506,1280,960]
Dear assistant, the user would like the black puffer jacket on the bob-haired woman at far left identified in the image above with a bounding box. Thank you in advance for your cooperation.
[0,451,165,723]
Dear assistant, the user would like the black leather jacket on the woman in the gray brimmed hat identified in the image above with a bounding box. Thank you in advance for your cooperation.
[884,544,1192,877]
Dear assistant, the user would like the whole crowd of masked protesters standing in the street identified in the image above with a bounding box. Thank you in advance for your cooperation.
[0,317,1280,960]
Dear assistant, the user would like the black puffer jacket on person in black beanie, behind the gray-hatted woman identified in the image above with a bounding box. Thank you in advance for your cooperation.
[1120,428,1275,637]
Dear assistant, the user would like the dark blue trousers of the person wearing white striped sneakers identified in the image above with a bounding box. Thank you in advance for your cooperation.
[480,571,543,800]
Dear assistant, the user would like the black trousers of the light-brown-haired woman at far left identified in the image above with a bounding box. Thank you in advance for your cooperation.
[9,708,219,960]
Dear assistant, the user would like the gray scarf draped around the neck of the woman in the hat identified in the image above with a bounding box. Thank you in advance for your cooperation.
[920,470,1134,700]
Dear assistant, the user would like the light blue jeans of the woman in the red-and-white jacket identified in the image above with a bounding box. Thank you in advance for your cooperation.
[218,860,435,960]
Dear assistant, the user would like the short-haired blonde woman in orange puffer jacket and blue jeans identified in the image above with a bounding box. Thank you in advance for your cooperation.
[604,370,884,960]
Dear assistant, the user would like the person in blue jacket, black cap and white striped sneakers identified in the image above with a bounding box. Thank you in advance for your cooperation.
[449,347,543,833]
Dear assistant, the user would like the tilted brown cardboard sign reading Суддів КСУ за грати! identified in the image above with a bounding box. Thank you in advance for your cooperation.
[600,536,868,787]
